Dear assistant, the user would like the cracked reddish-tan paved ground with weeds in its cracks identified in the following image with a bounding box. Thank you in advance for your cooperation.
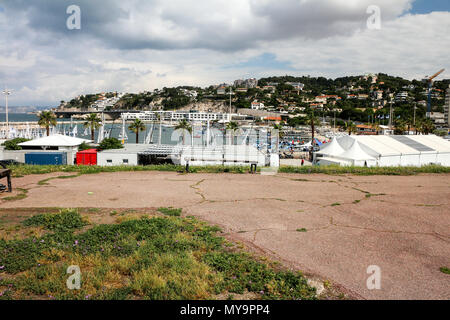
[0,172,450,299]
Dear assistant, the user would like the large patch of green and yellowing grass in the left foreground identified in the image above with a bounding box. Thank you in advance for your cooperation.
[0,210,315,300]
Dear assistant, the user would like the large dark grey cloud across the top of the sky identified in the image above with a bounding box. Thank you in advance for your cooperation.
[5,0,412,51]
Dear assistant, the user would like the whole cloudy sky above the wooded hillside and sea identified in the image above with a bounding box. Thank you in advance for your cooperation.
[0,0,450,106]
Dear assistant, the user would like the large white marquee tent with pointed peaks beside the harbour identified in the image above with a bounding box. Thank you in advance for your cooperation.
[315,135,450,167]
